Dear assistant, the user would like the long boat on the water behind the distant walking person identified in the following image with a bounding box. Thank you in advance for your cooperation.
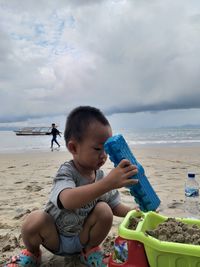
[14,127,52,135]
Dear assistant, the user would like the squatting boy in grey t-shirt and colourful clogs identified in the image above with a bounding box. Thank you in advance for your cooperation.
[5,106,137,267]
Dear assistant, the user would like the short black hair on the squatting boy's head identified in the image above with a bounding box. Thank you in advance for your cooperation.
[64,106,110,146]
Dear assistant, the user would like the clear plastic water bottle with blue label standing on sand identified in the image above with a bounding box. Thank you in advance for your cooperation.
[185,172,200,219]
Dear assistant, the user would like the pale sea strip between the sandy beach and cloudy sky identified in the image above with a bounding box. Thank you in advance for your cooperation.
[0,126,200,153]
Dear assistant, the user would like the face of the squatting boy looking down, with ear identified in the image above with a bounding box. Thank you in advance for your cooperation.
[73,121,112,171]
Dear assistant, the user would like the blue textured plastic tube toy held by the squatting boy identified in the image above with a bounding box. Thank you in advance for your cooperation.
[104,134,160,211]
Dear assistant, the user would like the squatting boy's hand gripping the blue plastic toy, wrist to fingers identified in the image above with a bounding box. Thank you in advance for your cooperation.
[105,159,138,189]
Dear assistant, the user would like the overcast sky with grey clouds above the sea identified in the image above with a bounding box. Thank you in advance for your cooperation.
[0,0,200,128]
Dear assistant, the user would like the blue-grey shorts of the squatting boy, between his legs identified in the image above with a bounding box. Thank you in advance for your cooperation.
[46,235,84,256]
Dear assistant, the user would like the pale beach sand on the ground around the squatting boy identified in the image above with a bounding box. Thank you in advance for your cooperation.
[0,147,200,267]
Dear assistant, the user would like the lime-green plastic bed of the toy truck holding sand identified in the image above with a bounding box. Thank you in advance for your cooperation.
[119,211,200,267]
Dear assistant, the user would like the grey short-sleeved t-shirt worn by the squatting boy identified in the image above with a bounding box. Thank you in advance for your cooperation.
[45,161,120,236]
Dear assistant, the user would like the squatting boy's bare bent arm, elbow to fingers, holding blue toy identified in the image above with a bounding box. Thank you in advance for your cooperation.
[59,159,137,210]
